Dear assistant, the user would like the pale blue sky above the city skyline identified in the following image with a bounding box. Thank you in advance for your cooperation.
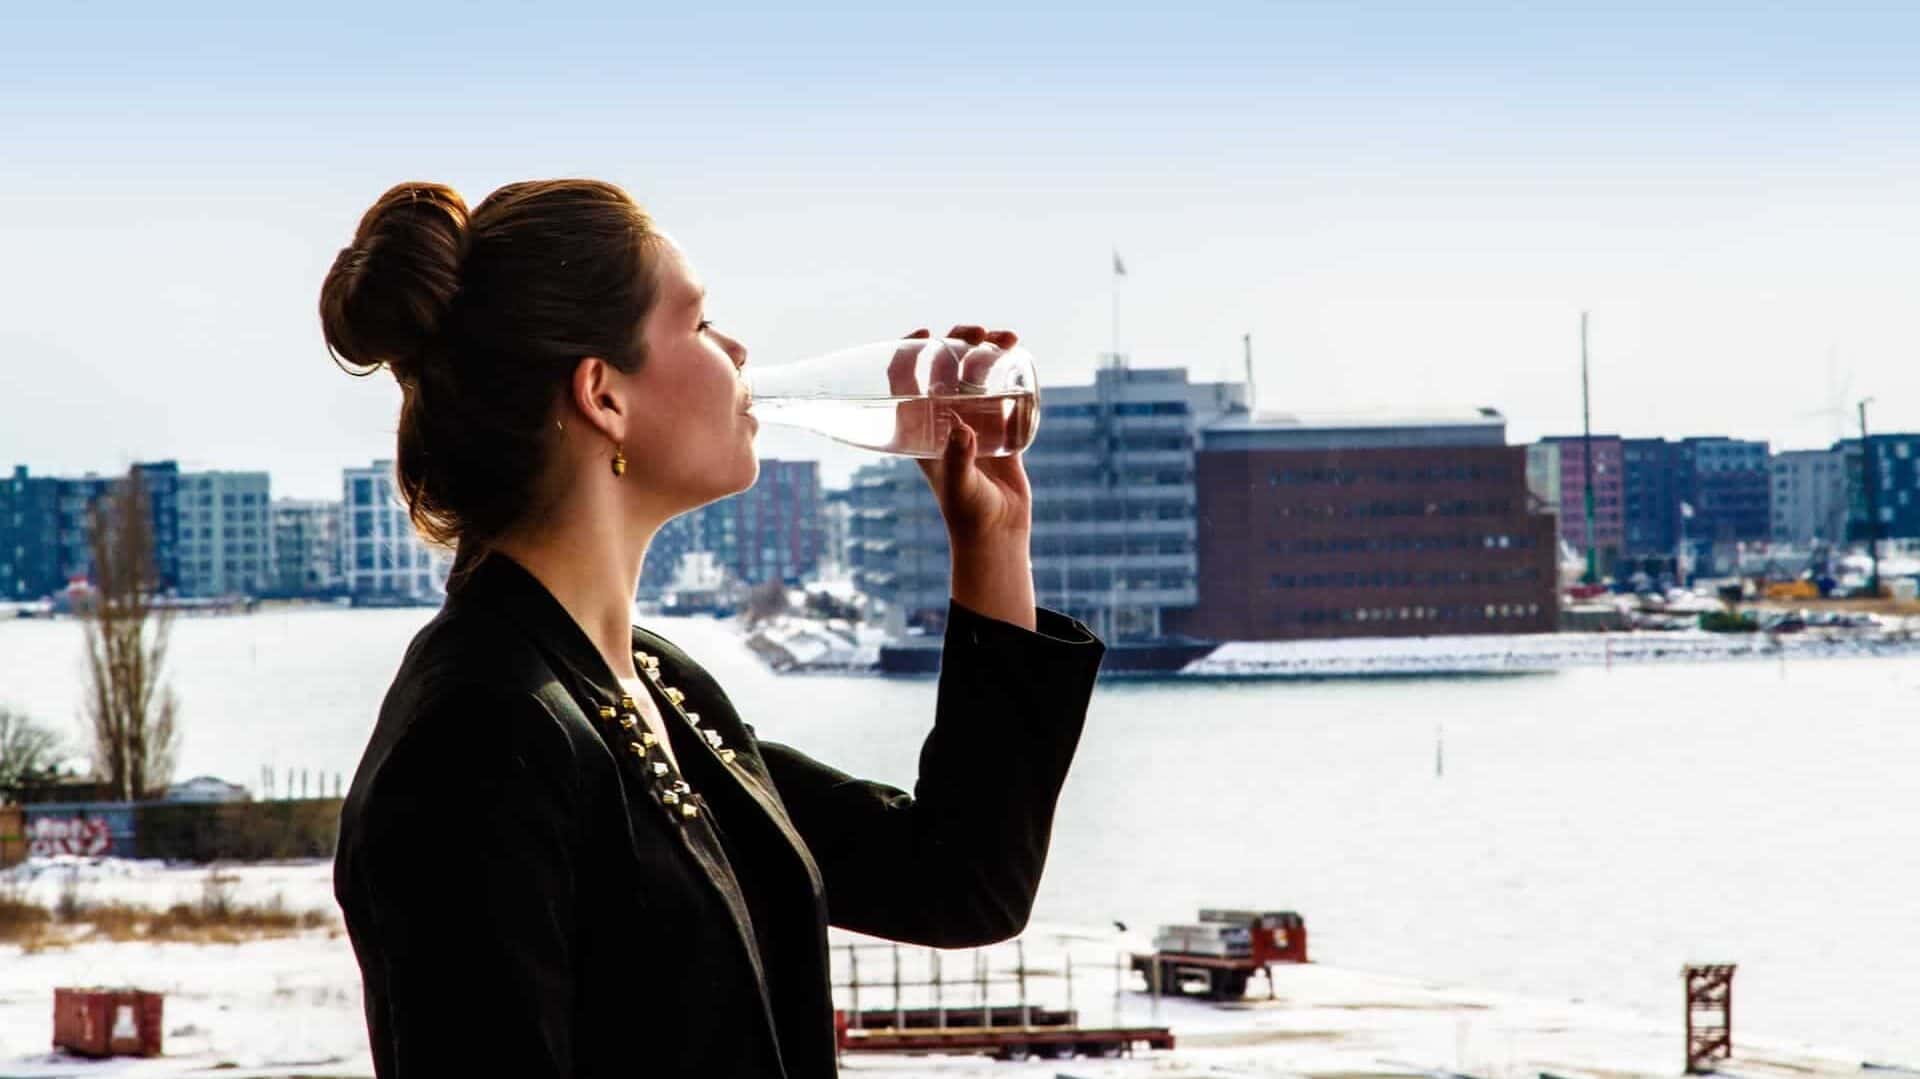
[0,2,1920,495]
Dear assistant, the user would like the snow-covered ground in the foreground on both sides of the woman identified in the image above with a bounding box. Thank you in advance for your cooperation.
[0,860,1889,1079]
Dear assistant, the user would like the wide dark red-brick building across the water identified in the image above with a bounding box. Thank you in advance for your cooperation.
[1171,413,1559,641]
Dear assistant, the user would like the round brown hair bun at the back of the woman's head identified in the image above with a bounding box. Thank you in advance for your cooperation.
[321,184,467,382]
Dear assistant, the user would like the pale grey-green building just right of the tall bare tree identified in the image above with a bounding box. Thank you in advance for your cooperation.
[175,472,275,597]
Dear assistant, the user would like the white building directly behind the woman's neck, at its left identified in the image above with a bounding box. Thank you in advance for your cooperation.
[340,461,453,605]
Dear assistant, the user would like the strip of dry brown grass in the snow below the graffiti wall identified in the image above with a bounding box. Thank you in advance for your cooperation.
[0,872,338,952]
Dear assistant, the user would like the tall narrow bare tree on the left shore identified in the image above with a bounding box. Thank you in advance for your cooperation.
[79,468,177,803]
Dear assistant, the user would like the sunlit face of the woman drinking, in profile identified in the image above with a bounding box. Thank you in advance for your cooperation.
[626,240,760,509]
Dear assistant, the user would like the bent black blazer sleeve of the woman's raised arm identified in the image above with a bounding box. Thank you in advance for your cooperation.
[760,603,1106,948]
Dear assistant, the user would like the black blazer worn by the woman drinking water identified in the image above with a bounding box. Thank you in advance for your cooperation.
[334,555,1104,1079]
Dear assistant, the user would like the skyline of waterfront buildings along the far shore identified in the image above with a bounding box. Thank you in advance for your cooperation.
[0,369,1920,637]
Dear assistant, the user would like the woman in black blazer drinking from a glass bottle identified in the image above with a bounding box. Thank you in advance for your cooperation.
[321,180,1102,1079]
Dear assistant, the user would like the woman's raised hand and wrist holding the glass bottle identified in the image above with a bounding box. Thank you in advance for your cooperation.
[887,326,1035,630]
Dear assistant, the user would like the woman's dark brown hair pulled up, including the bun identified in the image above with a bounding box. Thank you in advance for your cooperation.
[321,180,659,555]
